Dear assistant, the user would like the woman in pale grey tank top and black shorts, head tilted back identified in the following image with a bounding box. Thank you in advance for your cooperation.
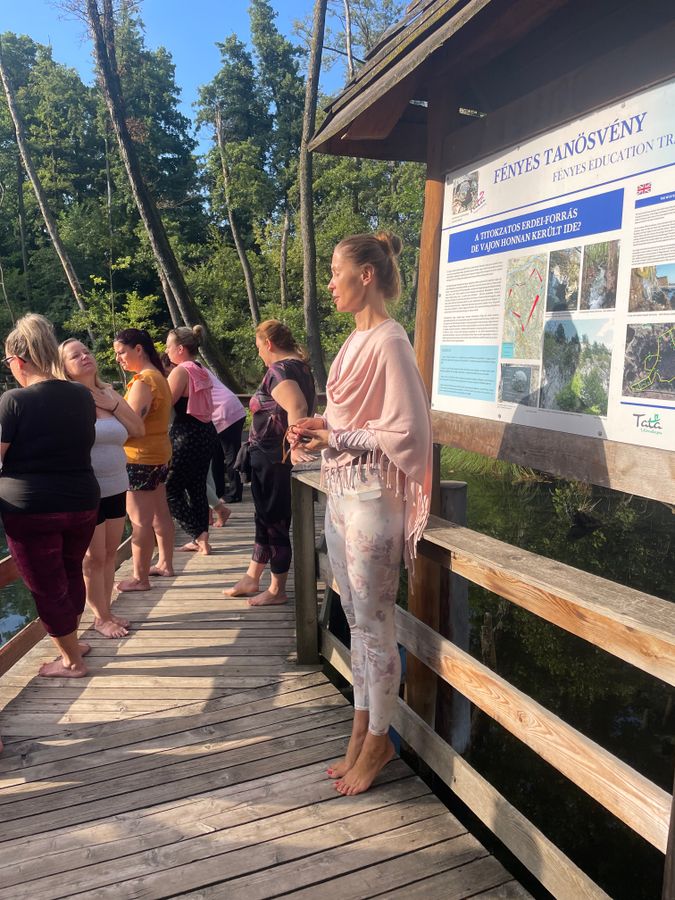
[59,338,145,638]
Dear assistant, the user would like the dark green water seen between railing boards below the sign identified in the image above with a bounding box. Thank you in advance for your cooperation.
[443,448,675,900]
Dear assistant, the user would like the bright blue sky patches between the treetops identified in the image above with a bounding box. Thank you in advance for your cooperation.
[0,0,343,144]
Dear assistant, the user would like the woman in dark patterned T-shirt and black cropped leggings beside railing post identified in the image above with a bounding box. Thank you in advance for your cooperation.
[224,319,316,606]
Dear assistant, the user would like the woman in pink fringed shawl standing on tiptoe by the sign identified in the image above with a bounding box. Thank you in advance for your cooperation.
[292,232,431,795]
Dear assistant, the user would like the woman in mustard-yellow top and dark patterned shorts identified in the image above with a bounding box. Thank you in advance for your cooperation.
[113,328,175,591]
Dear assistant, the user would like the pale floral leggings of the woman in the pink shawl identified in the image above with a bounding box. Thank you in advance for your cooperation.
[326,475,405,735]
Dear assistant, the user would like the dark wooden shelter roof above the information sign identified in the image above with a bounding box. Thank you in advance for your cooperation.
[310,0,673,162]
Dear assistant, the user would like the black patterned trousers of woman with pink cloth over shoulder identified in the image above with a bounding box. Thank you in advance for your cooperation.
[166,416,217,540]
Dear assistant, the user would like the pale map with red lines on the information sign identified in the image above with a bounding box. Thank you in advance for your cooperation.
[502,253,546,359]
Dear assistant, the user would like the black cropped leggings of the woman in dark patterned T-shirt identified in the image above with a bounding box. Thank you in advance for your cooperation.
[251,446,291,575]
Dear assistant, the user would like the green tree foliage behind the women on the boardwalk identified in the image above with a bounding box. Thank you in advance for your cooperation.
[0,0,424,386]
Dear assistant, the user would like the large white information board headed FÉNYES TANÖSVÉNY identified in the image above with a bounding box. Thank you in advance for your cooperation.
[432,82,675,450]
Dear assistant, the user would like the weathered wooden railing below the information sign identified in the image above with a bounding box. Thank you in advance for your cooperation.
[293,472,675,900]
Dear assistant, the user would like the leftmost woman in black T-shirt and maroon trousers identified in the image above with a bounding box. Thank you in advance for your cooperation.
[0,314,99,678]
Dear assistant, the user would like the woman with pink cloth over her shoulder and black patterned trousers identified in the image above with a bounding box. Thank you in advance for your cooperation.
[166,325,218,556]
